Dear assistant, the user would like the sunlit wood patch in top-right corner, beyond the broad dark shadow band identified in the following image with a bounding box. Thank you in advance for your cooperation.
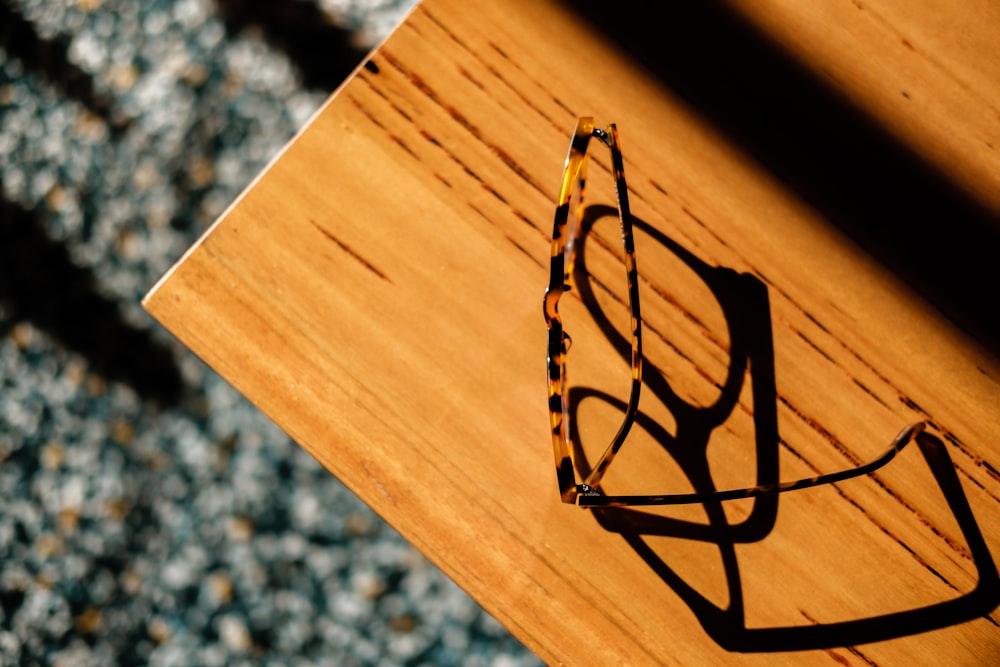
[731,0,1000,217]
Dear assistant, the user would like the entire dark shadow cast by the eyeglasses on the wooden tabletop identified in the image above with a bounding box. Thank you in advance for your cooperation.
[568,206,1000,652]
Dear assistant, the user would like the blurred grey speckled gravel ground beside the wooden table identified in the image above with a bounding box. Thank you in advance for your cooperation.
[0,0,538,667]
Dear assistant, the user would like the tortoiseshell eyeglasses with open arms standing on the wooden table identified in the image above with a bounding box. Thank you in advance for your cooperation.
[543,117,926,507]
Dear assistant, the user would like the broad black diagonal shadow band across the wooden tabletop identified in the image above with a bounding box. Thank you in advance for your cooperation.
[567,0,1000,353]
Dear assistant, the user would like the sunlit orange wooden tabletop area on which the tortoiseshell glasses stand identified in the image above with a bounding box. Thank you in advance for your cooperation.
[145,0,1000,665]
